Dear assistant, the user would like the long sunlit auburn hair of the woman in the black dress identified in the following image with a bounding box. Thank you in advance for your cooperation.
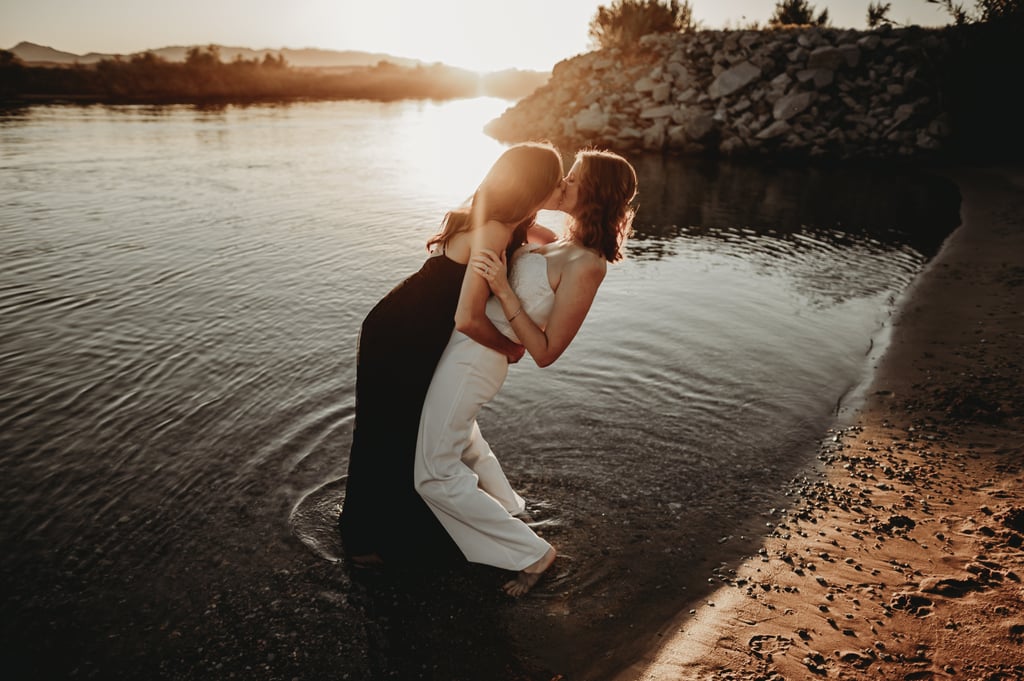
[427,142,564,258]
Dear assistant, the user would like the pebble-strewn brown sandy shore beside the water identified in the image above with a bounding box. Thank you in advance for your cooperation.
[616,161,1024,681]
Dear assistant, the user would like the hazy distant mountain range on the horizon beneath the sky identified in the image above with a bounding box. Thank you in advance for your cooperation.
[8,41,544,74]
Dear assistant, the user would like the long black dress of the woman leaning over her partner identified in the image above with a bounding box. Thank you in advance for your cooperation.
[339,255,466,562]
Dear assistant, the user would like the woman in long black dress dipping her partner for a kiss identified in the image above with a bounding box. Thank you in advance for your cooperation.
[339,142,562,565]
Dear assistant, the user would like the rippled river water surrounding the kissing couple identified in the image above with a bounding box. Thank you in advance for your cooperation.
[0,98,958,681]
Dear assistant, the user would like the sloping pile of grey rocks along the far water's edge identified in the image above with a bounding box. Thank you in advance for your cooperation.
[487,27,952,159]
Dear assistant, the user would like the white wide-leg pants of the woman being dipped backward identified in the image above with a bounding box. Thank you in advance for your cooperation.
[415,331,551,570]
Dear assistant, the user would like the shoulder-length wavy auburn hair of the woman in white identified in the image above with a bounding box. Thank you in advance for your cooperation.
[568,148,637,262]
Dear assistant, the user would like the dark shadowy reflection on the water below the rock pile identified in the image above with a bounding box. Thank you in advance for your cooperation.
[635,155,959,257]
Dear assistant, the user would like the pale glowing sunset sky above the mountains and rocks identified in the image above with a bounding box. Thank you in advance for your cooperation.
[0,0,950,72]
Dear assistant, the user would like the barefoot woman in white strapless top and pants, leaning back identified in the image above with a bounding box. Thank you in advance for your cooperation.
[415,150,637,596]
